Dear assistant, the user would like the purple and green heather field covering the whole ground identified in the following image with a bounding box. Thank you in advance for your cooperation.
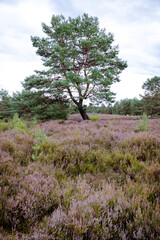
[0,114,160,240]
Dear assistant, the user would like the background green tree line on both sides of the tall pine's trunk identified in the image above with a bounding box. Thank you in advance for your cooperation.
[0,77,160,121]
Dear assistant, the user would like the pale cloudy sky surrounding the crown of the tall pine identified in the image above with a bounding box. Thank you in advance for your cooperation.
[0,0,160,101]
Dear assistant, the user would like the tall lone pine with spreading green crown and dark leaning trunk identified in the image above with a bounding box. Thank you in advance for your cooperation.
[23,14,127,119]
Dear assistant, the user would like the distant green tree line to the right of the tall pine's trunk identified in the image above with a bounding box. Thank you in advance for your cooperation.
[87,76,160,117]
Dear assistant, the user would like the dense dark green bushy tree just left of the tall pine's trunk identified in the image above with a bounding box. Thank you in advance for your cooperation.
[11,90,69,121]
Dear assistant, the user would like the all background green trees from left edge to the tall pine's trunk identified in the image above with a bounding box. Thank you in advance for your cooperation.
[0,89,69,121]
